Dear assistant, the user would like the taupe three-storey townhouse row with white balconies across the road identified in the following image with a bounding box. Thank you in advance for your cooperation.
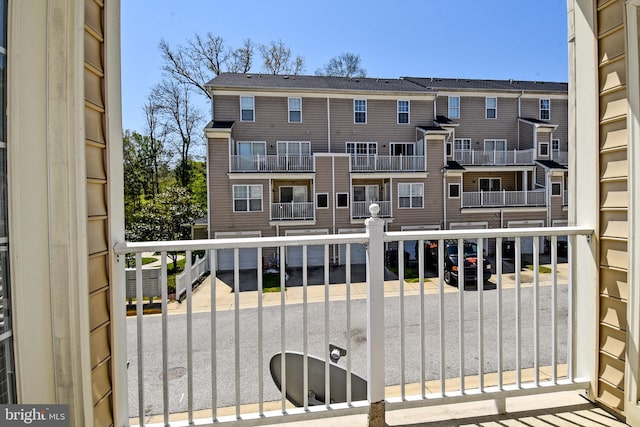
[205,73,568,270]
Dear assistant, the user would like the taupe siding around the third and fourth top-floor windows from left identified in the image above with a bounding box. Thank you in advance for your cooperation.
[331,96,433,155]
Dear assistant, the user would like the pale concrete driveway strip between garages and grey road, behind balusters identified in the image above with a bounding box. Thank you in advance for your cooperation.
[168,264,567,314]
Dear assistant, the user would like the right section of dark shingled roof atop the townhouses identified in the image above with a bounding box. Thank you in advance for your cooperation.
[403,77,569,93]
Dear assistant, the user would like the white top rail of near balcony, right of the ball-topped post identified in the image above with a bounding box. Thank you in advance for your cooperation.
[384,226,594,242]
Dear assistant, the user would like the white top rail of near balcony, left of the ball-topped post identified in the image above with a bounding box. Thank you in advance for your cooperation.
[113,233,368,255]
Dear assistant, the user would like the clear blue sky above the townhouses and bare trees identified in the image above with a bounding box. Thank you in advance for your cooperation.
[121,0,568,131]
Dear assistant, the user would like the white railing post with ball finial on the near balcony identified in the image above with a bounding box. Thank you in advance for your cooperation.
[365,203,385,427]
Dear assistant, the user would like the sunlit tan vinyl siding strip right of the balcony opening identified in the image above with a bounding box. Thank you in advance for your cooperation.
[596,0,629,413]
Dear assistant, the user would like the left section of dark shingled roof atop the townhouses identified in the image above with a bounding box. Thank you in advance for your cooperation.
[207,73,433,93]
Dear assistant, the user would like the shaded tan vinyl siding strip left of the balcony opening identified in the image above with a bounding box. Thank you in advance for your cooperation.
[84,0,113,426]
